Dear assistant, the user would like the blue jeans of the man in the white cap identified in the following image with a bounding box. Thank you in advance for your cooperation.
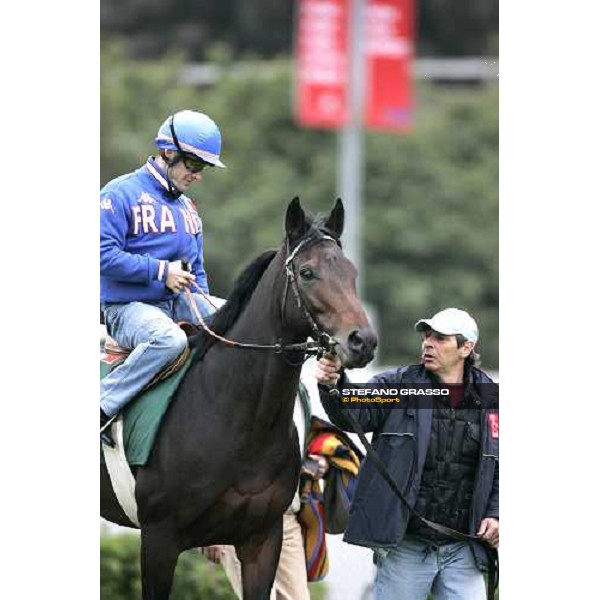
[375,535,486,600]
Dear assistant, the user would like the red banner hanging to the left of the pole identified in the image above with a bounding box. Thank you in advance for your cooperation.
[296,0,351,127]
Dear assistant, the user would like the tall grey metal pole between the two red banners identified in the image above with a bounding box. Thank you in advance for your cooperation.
[338,0,365,296]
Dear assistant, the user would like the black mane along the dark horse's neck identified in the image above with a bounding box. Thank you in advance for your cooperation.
[189,250,277,362]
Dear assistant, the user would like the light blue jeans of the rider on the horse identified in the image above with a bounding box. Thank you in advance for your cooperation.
[100,294,224,416]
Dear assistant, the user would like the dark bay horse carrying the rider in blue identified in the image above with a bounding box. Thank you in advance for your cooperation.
[100,198,377,600]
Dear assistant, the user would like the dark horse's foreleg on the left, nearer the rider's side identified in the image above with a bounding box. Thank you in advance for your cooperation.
[141,527,180,600]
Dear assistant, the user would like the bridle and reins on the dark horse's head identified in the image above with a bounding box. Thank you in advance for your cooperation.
[186,232,340,358]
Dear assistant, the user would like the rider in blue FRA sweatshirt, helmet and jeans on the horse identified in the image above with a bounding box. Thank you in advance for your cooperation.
[100,110,225,446]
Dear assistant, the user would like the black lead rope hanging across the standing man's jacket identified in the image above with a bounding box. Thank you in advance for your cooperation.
[326,386,500,600]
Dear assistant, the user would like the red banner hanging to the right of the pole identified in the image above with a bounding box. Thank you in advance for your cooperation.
[364,0,414,131]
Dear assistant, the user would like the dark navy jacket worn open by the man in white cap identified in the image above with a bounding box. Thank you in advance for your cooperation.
[319,365,499,568]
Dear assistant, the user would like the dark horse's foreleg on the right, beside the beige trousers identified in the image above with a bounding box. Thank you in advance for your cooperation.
[236,519,283,600]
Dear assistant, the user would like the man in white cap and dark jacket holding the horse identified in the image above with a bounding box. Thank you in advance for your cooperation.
[316,308,500,600]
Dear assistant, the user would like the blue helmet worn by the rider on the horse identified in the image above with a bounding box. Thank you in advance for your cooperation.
[154,110,225,167]
